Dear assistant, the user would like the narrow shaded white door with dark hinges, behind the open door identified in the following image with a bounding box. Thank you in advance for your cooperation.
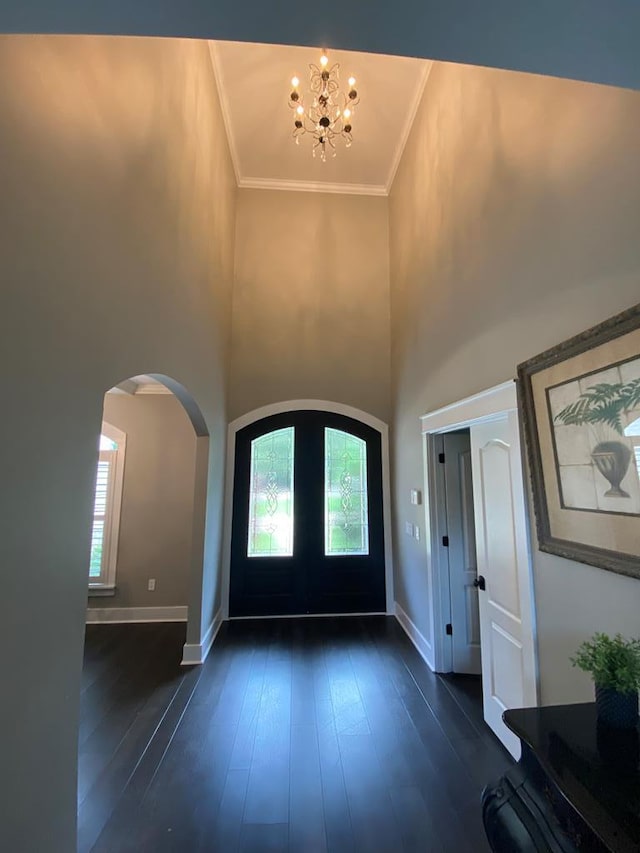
[444,432,481,675]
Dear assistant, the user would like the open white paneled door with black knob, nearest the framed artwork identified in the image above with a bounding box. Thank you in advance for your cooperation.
[471,412,537,758]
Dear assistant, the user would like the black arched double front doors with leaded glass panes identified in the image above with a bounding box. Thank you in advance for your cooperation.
[229,411,385,616]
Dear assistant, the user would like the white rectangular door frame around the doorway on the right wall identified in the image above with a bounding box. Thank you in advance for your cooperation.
[420,379,540,704]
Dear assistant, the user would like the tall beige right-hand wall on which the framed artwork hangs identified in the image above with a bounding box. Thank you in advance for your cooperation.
[389,64,640,703]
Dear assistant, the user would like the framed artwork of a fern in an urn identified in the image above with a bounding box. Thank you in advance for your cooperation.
[518,305,640,577]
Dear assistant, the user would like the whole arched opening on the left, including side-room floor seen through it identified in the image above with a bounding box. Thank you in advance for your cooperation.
[78,374,209,849]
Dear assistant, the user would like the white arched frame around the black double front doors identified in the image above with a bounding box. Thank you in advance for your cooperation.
[222,400,395,619]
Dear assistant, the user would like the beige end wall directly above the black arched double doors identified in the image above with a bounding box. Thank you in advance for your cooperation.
[229,189,389,421]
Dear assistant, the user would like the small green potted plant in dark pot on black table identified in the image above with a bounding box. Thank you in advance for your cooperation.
[570,633,640,729]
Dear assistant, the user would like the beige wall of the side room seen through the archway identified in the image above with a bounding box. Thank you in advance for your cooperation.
[89,394,196,609]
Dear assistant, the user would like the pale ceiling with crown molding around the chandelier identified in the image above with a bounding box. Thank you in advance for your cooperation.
[209,41,431,195]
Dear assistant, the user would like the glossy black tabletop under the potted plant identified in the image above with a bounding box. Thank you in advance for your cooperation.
[504,703,640,853]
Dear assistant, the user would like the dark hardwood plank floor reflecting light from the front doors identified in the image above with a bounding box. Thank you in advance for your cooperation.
[78,617,511,853]
